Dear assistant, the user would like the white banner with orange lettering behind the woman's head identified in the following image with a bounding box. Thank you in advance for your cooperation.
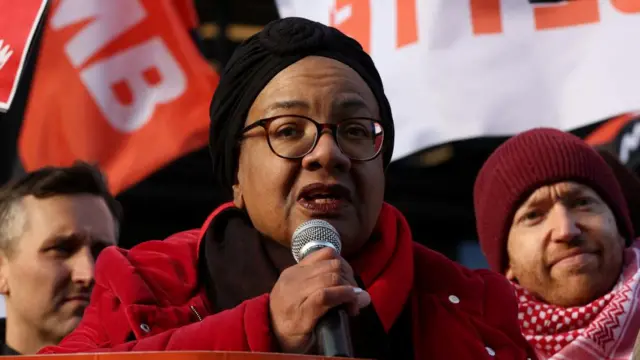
[277,0,640,159]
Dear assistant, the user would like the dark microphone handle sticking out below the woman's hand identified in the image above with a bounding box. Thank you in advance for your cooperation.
[316,306,353,358]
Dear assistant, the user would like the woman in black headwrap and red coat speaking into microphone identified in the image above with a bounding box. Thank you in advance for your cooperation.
[41,18,533,360]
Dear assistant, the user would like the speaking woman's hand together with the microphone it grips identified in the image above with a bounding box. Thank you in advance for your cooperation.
[269,220,371,356]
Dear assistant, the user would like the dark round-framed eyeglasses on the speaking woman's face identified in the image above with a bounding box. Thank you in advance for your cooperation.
[242,115,384,161]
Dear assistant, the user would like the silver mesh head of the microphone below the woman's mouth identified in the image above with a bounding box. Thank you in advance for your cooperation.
[291,219,342,262]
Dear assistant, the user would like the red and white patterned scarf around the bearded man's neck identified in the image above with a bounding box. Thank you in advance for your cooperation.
[514,241,640,360]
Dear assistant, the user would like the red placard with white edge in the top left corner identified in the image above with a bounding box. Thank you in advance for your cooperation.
[0,0,47,112]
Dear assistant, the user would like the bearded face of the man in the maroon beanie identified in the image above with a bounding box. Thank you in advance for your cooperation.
[506,182,625,307]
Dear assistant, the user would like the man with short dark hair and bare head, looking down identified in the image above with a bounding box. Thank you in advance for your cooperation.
[0,162,122,355]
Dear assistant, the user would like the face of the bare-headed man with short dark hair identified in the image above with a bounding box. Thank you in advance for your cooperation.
[0,195,116,341]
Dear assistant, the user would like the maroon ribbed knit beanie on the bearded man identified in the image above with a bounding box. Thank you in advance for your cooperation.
[473,128,634,273]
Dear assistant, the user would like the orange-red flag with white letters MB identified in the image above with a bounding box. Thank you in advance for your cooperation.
[19,0,218,193]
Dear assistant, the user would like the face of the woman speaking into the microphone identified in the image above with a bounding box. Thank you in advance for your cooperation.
[234,56,384,256]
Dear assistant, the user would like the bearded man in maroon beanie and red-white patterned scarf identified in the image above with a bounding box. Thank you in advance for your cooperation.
[474,128,640,360]
